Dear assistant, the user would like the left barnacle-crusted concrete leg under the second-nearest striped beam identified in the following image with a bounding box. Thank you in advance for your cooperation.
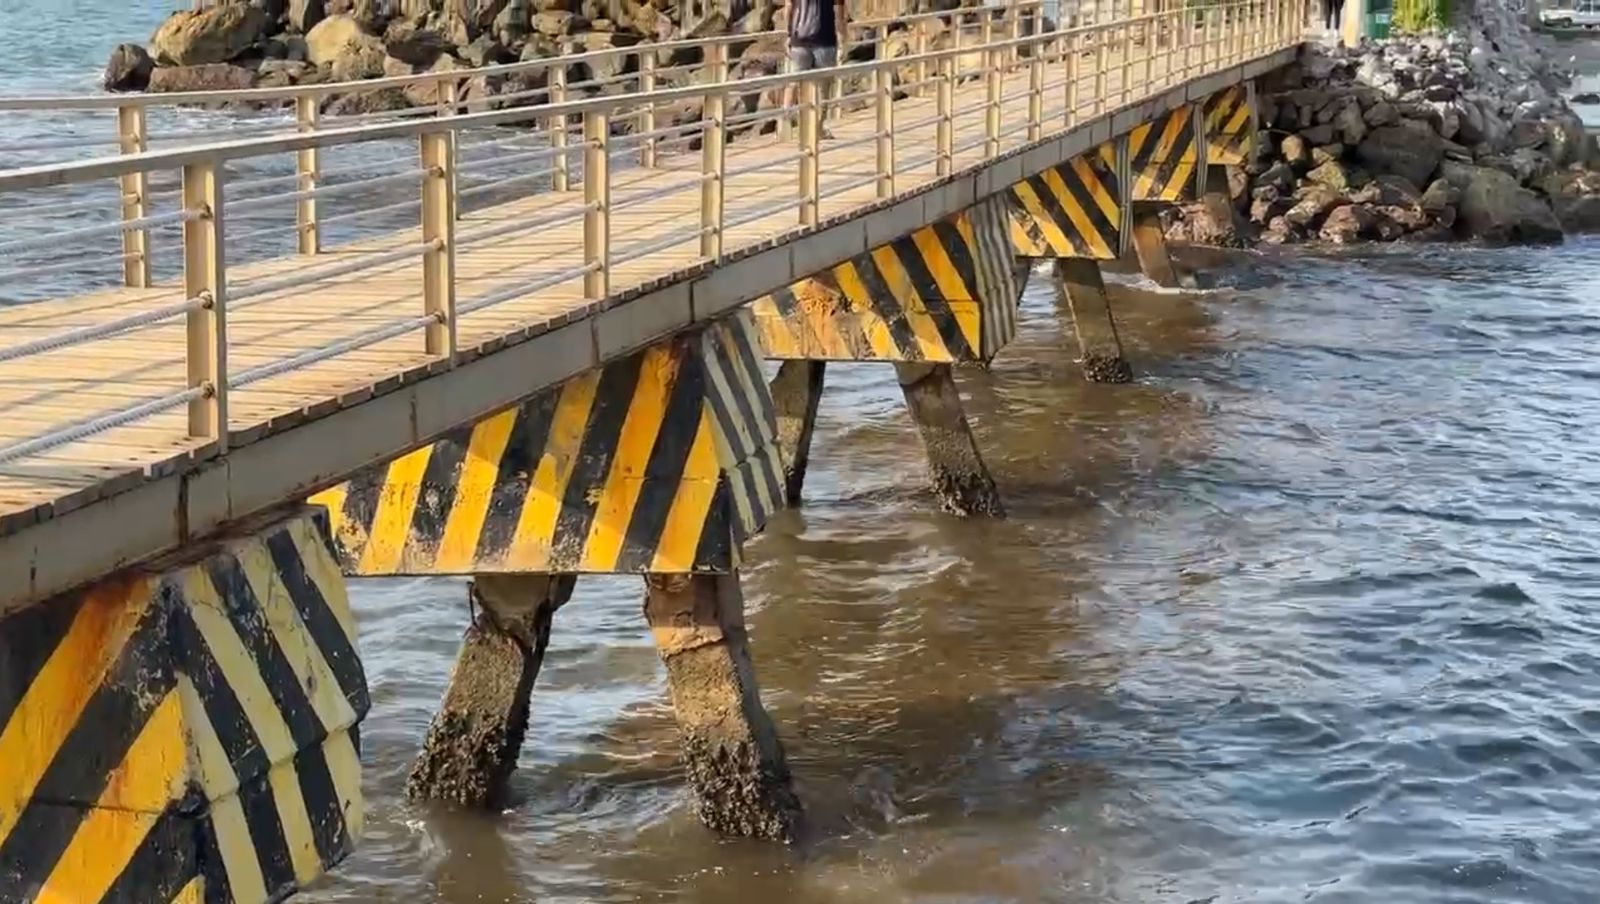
[405,574,576,806]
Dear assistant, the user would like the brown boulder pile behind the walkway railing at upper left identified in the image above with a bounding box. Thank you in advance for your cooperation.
[95,0,781,114]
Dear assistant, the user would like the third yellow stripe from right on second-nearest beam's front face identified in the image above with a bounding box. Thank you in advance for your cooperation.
[506,370,602,571]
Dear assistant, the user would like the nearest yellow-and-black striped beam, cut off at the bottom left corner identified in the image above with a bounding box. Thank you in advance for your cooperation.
[0,509,368,904]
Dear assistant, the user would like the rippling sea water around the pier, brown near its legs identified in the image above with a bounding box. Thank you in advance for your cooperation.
[0,0,1600,904]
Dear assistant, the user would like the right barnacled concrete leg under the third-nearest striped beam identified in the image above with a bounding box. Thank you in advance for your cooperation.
[894,363,1005,518]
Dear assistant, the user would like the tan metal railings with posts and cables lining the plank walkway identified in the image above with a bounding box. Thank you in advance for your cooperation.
[0,0,1306,464]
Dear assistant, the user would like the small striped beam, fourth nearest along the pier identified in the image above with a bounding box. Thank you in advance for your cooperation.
[1006,142,1123,261]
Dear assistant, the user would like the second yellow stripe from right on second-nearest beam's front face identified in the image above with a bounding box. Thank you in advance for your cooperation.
[584,346,682,571]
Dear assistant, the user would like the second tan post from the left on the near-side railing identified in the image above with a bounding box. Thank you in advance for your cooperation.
[421,130,456,358]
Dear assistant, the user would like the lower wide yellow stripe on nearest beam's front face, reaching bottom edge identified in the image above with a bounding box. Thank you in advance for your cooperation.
[37,691,187,904]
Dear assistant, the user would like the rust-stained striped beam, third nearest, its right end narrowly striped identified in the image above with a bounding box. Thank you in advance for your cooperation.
[750,198,1026,363]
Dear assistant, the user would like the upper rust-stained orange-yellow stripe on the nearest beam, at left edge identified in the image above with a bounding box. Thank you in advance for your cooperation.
[0,579,152,842]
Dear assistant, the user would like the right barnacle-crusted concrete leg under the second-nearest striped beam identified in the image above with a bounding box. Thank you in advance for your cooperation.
[645,573,800,842]
